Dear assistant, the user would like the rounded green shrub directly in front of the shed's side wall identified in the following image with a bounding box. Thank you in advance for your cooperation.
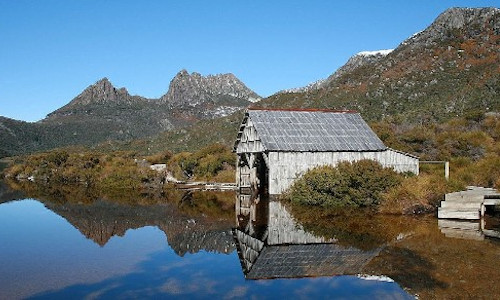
[284,160,403,207]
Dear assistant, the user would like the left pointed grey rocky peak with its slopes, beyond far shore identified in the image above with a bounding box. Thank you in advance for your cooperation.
[32,78,174,149]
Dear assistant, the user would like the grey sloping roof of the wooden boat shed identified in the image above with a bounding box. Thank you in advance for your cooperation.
[247,109,387,152]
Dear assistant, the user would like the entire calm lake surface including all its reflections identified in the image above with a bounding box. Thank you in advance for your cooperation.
[0,182,500,299]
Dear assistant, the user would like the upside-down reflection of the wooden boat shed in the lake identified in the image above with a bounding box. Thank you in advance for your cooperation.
[233,195,380,279]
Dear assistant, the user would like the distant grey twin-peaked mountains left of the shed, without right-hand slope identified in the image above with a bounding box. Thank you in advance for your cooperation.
[0,70,260,157]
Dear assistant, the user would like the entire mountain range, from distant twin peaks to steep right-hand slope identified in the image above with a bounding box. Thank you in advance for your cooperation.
[0,8,500,156]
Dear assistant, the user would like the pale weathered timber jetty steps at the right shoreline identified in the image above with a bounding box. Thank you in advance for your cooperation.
[438,186,500,220]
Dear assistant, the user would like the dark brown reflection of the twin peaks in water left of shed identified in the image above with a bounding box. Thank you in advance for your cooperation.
[36,196,235,256]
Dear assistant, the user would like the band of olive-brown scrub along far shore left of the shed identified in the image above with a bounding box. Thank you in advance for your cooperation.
[4,144,236,198]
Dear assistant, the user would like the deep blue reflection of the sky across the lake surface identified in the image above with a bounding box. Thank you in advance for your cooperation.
[0,200,408,299]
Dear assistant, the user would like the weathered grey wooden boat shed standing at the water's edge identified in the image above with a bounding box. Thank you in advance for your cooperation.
[234,109,418,194]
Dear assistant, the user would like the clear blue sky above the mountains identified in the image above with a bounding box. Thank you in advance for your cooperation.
[0,0,500,121]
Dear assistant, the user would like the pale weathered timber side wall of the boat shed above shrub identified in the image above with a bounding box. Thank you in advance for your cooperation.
[268,149,418,194]
